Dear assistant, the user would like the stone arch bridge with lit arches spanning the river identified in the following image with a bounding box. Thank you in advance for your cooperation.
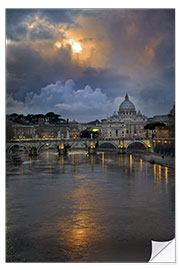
[6,138,153,155]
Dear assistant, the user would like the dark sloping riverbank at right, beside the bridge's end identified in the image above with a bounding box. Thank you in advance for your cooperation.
[135,152,175,169]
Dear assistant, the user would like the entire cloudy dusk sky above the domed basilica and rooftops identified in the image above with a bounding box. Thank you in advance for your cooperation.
[6,9,175,122]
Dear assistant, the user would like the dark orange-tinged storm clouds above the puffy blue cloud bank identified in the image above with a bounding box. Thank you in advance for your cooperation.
[6,9,175,119]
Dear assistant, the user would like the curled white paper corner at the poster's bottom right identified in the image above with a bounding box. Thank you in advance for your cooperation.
[149,239,175,263]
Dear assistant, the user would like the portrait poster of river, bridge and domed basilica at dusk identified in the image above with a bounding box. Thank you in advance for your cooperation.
[6,5,175,263]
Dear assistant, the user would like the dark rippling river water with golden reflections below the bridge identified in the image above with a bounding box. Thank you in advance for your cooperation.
[6,152,175,262]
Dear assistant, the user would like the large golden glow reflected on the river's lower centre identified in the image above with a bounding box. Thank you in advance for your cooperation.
[59,185,100,261]
